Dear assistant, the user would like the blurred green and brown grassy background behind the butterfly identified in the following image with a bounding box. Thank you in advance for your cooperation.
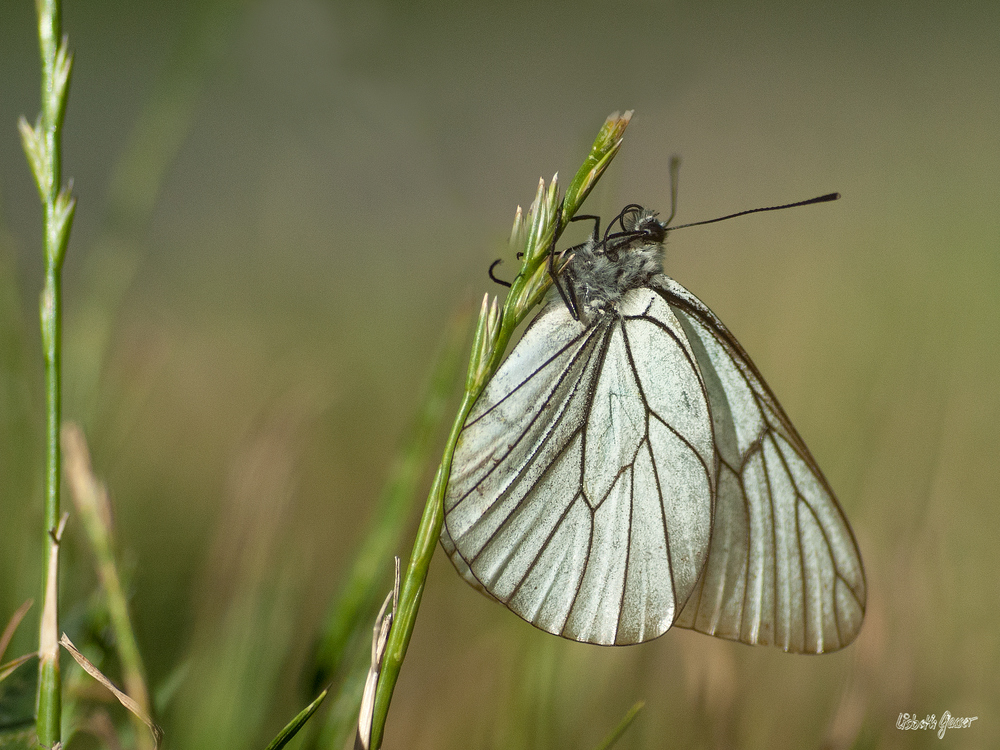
[0,0,1000,748]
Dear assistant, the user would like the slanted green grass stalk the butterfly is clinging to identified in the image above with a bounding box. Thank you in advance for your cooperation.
[370,112,631,748]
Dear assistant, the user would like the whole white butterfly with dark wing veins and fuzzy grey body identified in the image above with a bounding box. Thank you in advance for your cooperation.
[441,201,866,653]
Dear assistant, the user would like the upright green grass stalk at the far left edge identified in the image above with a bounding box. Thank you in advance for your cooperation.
[18,0,75,747]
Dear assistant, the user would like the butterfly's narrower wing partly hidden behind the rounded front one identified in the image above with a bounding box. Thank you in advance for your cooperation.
[651,275,866,653]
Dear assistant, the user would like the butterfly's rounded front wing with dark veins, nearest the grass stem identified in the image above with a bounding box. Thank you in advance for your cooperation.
[441,289,716,644]
